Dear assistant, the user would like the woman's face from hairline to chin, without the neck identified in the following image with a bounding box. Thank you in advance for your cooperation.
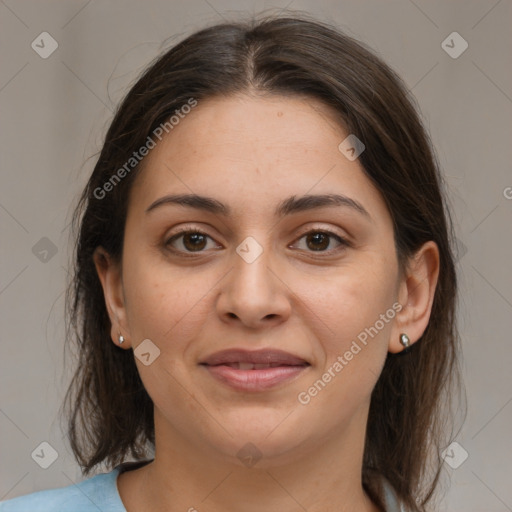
[99,96,408,465]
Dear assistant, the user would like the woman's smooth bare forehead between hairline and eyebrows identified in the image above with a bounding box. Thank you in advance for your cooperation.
[127,95,386,221]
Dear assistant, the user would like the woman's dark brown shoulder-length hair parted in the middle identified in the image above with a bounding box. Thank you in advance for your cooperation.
[65,16,460,511]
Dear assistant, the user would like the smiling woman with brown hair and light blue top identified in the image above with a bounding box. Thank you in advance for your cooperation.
[0,13,458,512]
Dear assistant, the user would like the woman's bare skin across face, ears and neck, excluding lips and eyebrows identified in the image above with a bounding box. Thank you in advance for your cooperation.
[95,94,439,512]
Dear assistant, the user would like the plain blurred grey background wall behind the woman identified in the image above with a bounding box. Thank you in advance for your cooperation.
[0,0,512,512]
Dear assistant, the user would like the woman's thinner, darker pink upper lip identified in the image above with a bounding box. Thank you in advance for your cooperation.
[200,349,309,366]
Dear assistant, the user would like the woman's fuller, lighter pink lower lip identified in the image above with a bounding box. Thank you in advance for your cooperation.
[202,365,308,391]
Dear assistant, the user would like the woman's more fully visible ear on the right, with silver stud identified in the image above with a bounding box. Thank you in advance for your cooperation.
[388,241,439,354]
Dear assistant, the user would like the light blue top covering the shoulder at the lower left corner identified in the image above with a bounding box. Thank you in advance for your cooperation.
[0,467,126,512]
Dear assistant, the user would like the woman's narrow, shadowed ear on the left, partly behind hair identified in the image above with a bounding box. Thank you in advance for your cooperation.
[93,247,131,348]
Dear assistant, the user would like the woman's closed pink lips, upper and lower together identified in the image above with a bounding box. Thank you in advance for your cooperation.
[200,349,311,392]
